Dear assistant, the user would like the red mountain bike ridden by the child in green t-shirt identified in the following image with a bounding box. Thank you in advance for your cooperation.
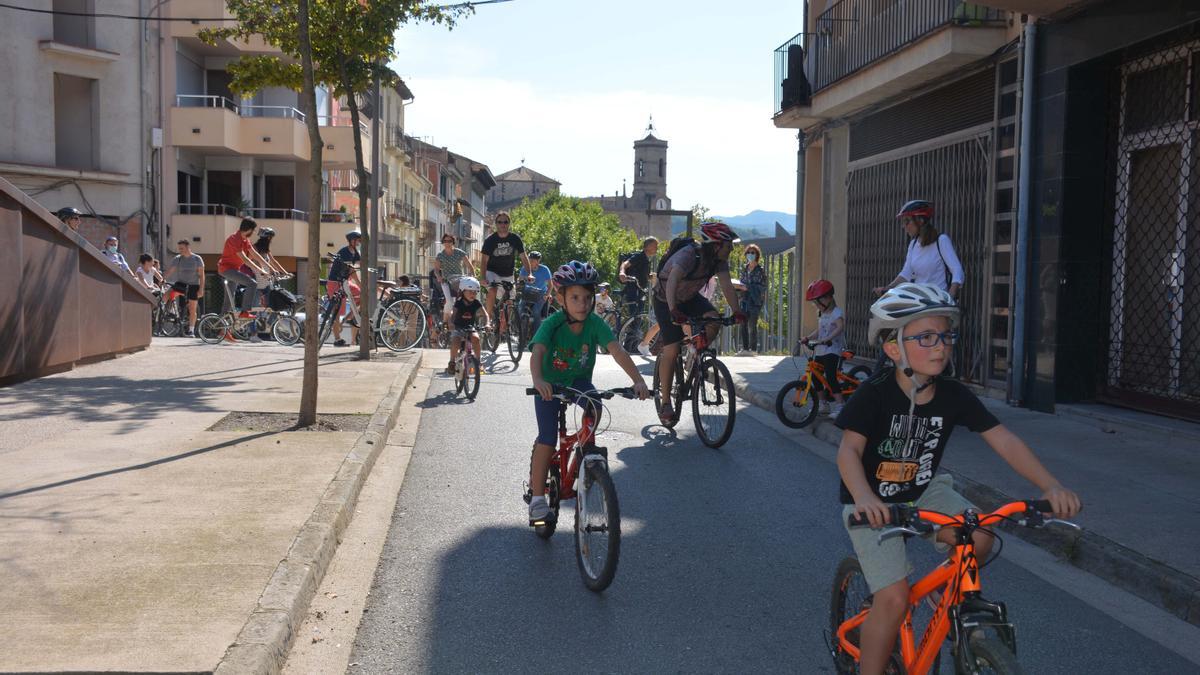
[524,384,637,592]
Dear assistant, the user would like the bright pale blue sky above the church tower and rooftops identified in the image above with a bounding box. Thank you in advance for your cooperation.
[391,0,804,216]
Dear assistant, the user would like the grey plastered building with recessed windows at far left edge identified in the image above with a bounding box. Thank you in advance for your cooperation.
[0,0,162,255]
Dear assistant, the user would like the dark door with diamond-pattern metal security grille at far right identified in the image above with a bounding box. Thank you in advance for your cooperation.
[1104,41,1200,416]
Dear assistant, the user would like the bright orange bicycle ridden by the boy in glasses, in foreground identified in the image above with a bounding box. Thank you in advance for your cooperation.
[829,500,1079,675]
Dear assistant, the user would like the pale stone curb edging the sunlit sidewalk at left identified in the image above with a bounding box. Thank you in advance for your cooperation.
[212,350,424,675]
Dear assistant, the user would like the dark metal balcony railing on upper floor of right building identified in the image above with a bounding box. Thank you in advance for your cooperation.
[775,0,1008,114]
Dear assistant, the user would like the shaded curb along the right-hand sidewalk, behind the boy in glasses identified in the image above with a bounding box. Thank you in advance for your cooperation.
[733,377,1200,626]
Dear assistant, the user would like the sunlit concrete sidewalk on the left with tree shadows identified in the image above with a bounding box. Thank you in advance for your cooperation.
[0,339,420,673]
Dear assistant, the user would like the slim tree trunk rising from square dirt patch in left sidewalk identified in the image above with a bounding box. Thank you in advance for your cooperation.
[298,0,325,426]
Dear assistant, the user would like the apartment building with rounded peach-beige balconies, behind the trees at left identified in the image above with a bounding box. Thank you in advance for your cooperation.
[160,0,372,281]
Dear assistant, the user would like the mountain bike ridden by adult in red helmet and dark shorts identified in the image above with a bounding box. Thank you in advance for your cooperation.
[653,317,738,448]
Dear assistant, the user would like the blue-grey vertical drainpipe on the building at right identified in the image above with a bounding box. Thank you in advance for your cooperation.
[1008,18,1038,406]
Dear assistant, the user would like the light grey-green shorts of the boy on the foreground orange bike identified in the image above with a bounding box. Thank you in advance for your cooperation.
[841,473,976,593]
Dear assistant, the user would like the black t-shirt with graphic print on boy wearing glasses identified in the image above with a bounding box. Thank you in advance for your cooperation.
[834,369,1000,504]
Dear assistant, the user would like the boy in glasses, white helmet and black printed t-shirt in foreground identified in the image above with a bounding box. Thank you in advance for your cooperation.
[836,283,1080,675]
